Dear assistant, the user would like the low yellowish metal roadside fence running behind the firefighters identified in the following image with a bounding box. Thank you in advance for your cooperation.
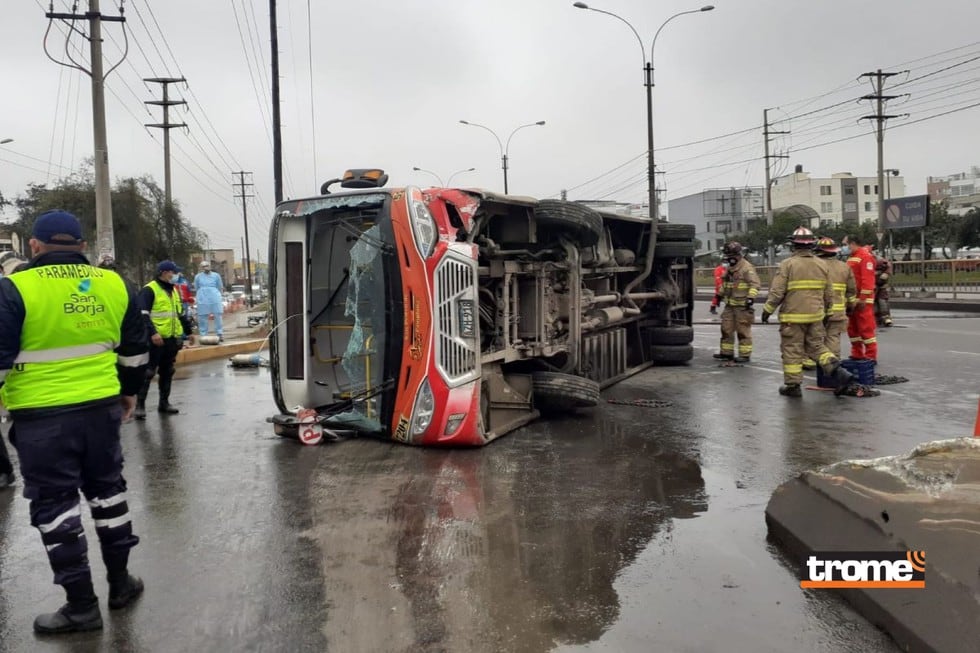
[694,259,980,299]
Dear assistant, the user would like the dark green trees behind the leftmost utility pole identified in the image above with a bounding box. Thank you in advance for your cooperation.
[13,166,205,280]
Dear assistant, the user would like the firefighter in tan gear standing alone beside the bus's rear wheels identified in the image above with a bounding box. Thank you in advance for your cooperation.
[715,241,761,363]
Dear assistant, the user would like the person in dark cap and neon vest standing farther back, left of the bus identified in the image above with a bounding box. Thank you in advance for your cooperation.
[134,261,191,420]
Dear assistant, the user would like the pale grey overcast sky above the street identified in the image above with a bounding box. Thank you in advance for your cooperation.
[0,0,980,253]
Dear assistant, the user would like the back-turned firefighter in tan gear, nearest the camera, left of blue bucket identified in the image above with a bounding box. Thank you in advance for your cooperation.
[762,227,853,397]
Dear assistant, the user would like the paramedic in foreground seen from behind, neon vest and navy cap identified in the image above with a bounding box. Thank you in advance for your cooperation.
[0,211,148,633]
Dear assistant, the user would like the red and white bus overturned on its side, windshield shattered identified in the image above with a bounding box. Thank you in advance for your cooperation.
[269,170,694,445]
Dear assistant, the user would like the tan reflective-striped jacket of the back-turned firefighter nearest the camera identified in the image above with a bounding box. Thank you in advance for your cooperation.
[763,249,834,324]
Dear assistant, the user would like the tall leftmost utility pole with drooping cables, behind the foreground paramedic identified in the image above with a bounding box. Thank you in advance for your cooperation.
[45,0,126,260]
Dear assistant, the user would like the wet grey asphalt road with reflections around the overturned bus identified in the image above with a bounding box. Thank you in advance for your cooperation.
[0,308,980,652]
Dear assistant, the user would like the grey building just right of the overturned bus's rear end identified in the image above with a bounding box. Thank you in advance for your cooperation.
[667,186,765,256]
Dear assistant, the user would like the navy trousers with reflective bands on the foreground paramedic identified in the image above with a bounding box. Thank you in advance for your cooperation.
[10,404,139,585]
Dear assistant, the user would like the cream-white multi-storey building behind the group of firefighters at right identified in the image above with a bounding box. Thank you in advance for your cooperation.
[772,165,905,228]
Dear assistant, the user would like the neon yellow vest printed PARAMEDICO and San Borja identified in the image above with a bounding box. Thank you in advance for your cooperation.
[0,264,129,410]
